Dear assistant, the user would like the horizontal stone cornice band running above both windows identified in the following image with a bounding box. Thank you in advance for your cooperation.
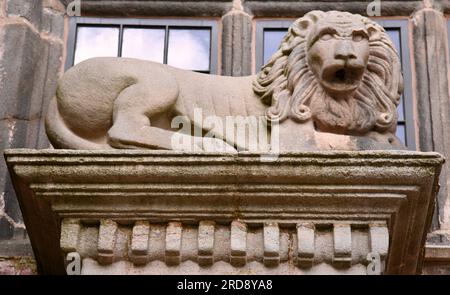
[62,0,422,18]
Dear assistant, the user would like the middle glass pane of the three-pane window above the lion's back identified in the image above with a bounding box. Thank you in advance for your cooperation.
[122,28,166,63]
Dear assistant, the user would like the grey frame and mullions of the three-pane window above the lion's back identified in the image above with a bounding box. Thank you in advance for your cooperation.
[65,17,219,74]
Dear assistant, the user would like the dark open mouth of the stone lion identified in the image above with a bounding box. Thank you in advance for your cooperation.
[322,65,364,92]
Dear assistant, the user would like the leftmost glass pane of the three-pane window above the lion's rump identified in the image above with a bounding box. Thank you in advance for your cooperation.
[74,26,119,64]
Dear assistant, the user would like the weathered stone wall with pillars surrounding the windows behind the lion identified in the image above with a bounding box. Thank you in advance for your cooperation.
[0,0,450,274]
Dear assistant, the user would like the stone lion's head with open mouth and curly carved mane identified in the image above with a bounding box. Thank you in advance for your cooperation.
[253,11,403,135]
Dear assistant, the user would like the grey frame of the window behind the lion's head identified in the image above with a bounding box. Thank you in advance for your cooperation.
[255,18,416,150]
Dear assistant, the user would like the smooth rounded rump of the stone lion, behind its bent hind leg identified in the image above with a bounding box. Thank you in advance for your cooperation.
[57,58,159,138]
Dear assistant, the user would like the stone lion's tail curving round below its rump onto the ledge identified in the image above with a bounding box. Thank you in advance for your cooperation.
[45,96,111,150]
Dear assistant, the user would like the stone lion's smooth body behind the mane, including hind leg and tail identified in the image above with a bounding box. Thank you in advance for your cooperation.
[46,58,265,152]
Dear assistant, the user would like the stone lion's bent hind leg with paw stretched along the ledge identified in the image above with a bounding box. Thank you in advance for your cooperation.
[108,81,235,152]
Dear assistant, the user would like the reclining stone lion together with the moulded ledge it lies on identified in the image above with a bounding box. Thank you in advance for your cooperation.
[5,11,443,274]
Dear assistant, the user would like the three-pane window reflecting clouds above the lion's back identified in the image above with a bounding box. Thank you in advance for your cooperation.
[66,17,218,73]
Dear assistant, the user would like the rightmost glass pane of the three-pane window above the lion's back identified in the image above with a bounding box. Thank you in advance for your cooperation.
[167,29,211,71]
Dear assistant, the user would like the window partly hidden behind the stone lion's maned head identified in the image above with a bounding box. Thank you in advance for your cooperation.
[256,20,416,150]
